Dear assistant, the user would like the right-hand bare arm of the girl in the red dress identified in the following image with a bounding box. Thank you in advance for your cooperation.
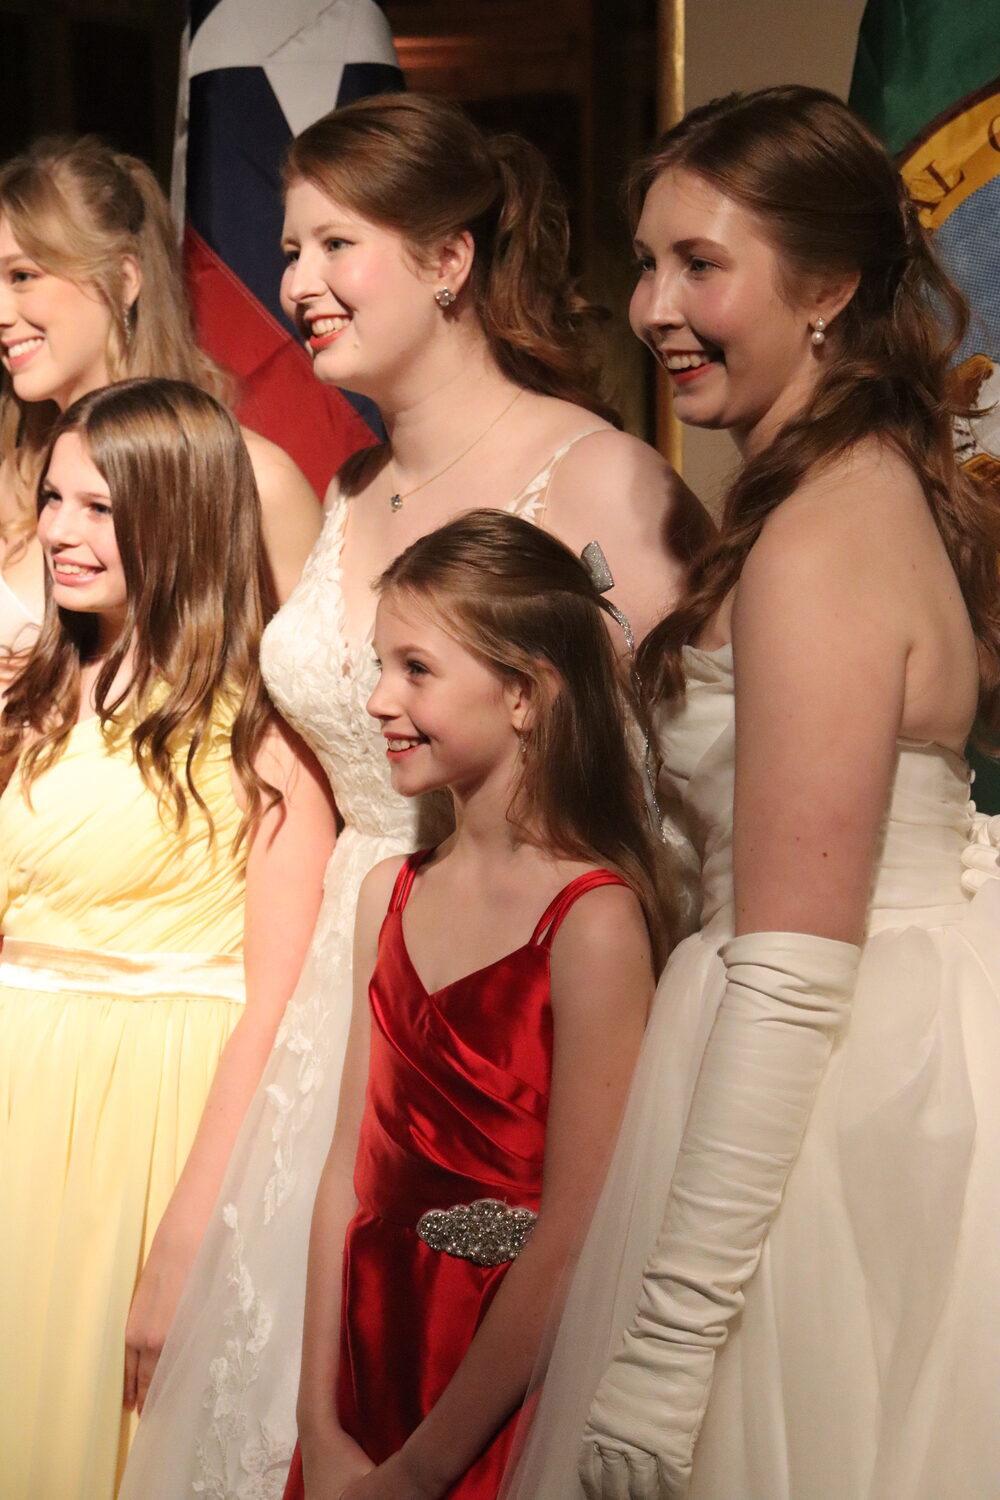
[345,887,654,1500]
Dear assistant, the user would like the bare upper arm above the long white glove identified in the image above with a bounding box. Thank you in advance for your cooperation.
[733,492,912,942]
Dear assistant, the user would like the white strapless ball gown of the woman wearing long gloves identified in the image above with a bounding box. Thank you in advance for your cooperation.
[504,648,1000,1500]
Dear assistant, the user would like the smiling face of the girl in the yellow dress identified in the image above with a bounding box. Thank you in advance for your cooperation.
[37,432,127,642]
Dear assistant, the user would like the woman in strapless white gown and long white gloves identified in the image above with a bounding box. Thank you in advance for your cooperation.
[505,87,1000,1500]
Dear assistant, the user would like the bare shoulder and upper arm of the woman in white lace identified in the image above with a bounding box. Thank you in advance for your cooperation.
[546,431,712,641]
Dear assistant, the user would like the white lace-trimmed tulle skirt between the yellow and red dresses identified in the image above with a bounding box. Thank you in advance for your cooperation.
[118,828,409,1500]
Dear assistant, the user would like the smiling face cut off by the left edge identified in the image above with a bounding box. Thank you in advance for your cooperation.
[0,221,111,411]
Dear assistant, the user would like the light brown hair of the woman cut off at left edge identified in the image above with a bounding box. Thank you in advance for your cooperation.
[0,135,229,555]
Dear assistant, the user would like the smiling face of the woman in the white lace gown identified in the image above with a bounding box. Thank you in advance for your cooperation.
[282,180,441,401]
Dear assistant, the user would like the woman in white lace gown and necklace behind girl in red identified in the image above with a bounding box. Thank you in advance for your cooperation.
[123,95,703,1500]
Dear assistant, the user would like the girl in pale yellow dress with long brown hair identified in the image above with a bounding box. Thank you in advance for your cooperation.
[0,380,334,1500]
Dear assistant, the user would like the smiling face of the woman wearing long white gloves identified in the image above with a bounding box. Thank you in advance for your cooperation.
[630,168,819,455]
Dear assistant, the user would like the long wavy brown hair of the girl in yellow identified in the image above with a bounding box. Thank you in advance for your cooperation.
[0,380,277,845]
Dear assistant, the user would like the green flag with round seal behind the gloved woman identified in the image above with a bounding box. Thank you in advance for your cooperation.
[849,0,1000,813]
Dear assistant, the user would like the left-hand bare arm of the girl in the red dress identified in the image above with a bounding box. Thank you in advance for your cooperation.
[298,860,400,1497]
